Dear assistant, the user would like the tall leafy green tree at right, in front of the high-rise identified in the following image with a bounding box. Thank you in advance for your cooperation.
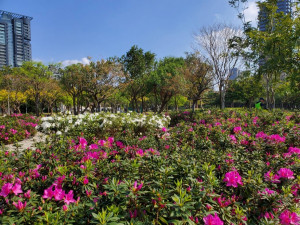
[229,0,300,108]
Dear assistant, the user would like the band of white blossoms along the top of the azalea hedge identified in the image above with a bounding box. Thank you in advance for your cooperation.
[38,113,171,135]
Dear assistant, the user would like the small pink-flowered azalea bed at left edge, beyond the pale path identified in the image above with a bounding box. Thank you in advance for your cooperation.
[0,114,39,144]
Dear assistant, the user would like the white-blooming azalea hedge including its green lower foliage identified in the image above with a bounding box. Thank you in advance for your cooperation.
[38,112,171,140]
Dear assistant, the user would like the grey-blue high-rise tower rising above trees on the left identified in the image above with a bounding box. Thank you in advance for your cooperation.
[0,10,32,68]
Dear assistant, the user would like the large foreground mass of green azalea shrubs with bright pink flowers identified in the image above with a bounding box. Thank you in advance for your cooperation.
[0,110,300,225]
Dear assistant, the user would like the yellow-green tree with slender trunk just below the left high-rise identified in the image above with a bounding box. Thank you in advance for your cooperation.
[21,62,52,116]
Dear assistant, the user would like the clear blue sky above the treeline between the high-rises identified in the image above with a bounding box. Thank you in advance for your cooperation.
[0,0,256,64]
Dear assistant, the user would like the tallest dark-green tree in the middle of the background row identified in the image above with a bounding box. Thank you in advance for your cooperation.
[121,45,155,111]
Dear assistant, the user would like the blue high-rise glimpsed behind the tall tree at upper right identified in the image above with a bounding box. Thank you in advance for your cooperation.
[258,0,292,31]
